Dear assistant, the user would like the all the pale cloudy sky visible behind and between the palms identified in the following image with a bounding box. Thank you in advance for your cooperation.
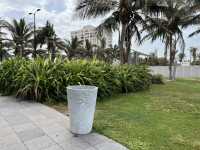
[0,0,200,56]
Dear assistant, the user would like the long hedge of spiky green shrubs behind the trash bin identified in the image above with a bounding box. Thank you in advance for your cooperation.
[0,58,151,102]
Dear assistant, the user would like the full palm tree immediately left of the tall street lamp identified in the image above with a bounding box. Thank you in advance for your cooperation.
[2,19,33,56]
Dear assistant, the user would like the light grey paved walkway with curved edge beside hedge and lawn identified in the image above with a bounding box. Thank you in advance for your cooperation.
[0,97,127,150]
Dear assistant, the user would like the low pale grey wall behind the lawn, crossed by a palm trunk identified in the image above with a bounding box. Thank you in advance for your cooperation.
[150,66,200,78]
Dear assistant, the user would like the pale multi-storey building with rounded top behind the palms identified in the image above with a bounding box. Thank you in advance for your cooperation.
[71,26,112,48]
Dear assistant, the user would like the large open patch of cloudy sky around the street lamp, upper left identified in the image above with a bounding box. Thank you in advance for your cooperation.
[0,0,102,38]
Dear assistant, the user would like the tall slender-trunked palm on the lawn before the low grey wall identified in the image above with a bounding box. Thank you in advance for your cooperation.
[143,0,198,80]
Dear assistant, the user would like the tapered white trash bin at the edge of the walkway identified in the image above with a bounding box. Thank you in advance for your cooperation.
[67,85,98,135]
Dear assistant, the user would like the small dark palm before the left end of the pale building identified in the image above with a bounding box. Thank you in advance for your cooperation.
[65,37,83,59]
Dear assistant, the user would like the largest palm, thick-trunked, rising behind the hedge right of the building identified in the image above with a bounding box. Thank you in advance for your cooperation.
[77,0,162,63]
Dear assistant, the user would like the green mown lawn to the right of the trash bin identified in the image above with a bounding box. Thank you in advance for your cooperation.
[49,80,200,150]
